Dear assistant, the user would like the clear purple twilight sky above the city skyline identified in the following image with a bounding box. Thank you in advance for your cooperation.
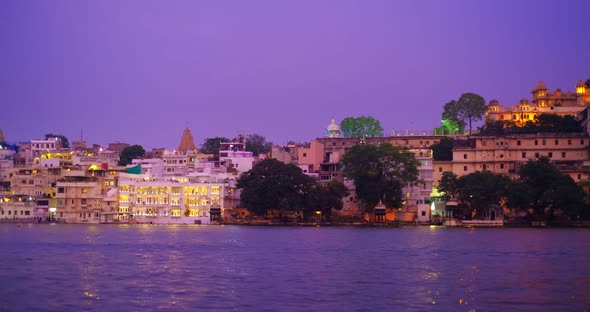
[0,0,590,149]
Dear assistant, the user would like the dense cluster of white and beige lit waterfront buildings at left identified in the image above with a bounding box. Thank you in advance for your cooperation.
[0,129,254,224]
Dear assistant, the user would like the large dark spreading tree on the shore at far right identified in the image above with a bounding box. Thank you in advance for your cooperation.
[508,157,585,222]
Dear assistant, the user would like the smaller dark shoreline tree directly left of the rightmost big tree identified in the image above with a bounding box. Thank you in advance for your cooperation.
[457,171,510,218]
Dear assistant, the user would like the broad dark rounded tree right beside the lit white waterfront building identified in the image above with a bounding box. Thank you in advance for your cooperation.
[237,158,316,215]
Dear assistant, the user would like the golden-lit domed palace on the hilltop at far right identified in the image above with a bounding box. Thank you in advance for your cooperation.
[486,80,590,126]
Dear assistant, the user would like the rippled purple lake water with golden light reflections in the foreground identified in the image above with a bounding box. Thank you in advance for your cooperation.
[0,224,590,311]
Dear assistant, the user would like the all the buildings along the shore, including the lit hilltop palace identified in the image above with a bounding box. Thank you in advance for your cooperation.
[0,82,590,224]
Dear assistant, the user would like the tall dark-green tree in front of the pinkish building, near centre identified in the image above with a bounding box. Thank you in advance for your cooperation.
[342,143,420,219]
